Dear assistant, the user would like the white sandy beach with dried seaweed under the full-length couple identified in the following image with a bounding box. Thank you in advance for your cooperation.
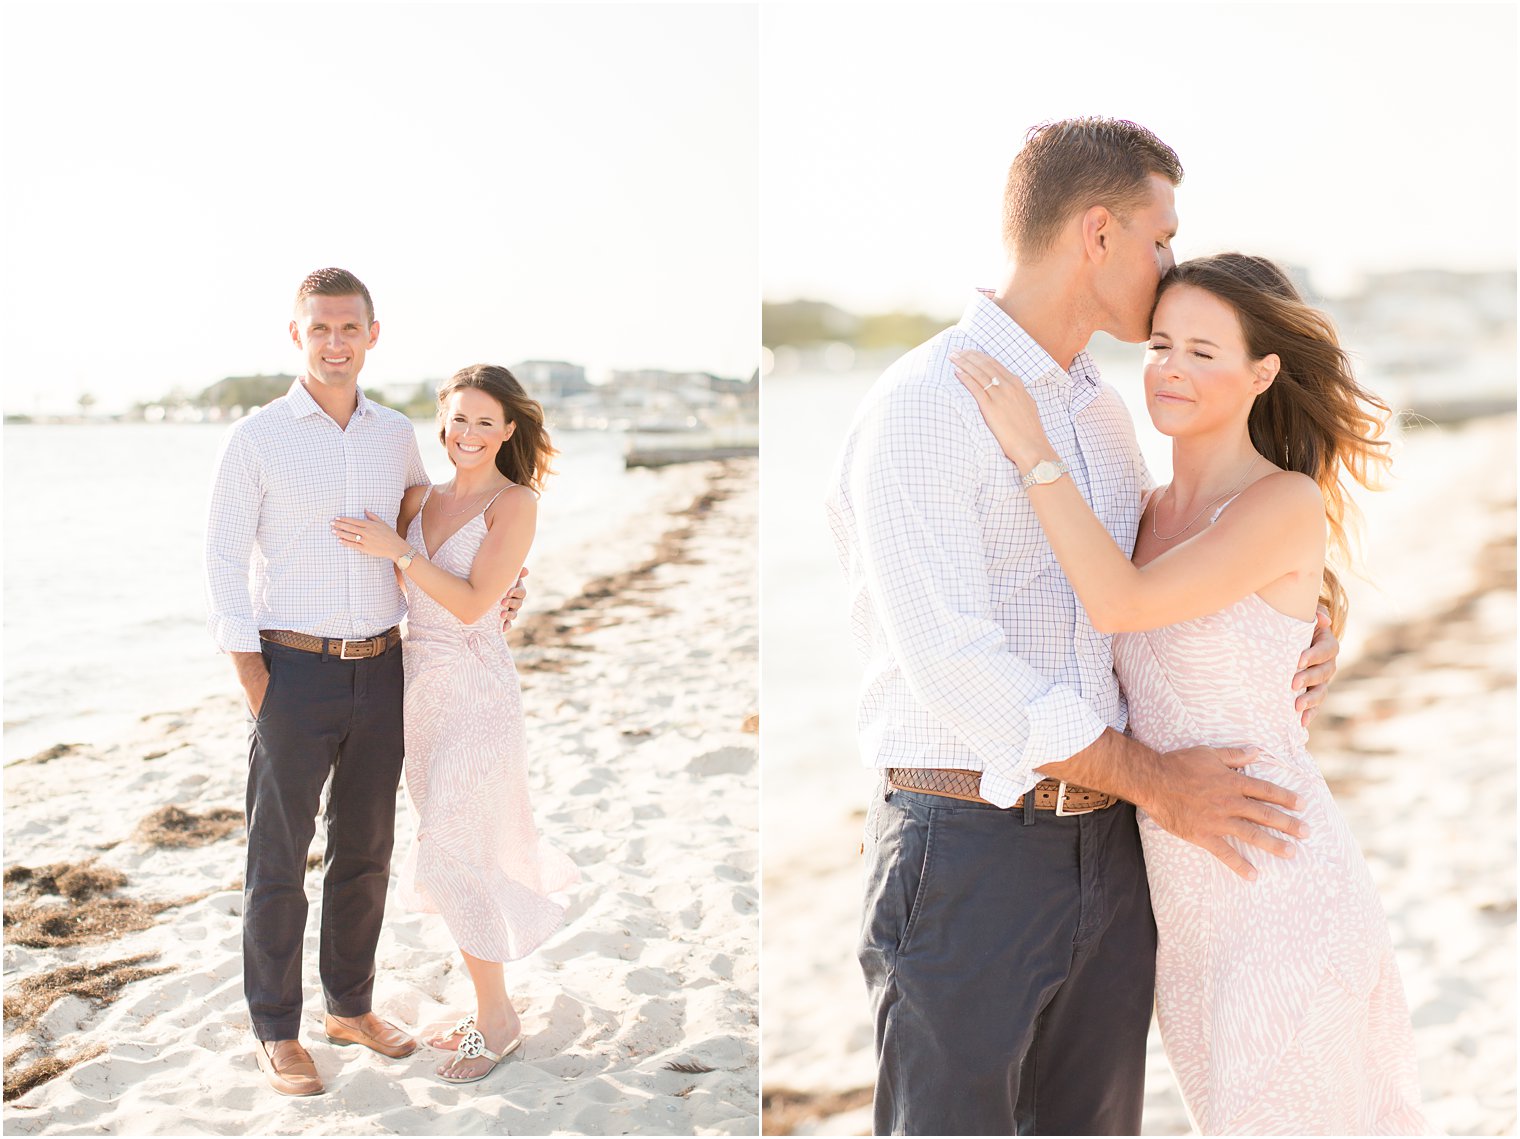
[5,461,758,1134]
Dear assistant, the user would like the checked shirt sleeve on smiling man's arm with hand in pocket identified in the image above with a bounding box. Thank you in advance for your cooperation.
[205,430,263,652]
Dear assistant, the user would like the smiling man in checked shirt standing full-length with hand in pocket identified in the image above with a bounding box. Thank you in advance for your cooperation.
[205,269,521,1095]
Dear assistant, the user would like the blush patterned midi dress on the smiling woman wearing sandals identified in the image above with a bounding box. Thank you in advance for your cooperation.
[400,490,578,961]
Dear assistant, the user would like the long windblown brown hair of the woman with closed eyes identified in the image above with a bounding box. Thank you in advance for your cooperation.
[1161,252,1391,636]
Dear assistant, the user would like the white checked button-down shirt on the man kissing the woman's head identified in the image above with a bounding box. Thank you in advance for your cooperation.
[827,295,1149,806]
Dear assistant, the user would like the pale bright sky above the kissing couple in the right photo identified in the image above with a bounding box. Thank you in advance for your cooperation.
[760,3,1517,318]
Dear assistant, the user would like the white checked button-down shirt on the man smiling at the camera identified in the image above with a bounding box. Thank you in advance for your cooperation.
[205,379,427,652]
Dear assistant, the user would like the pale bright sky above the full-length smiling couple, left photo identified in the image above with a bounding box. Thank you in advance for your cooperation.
[0,3,760,412]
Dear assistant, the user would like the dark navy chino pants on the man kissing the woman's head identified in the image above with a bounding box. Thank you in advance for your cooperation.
[860,785,1155,1134]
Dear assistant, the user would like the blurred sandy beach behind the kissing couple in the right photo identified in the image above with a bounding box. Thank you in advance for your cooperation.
[762,417,1515,1134]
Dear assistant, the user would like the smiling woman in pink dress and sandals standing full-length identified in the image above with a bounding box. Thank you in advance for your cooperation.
[333,365,576,1083]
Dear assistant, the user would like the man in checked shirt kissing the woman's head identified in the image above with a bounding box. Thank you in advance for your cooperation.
[828,119,1338,1134]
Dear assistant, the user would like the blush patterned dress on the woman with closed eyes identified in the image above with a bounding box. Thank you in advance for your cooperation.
[1114,580,1435,1134]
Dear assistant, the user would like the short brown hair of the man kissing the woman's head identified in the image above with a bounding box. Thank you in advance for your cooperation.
[1003,119,1183,259]
